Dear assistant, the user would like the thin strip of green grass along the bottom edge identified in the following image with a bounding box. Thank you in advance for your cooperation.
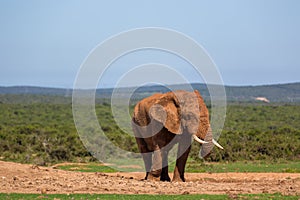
[0,193,298,200]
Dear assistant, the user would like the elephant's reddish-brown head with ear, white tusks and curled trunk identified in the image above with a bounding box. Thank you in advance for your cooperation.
[149,90,223,154]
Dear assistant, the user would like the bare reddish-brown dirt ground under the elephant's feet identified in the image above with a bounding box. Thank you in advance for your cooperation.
[0,161,300,195]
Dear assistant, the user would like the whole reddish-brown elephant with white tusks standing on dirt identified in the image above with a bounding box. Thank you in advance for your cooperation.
[132,90,223,182]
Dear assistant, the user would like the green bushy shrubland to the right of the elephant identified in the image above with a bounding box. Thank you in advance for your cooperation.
[192,104,300,161]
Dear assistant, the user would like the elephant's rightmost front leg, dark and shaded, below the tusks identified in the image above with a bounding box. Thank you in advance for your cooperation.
[172,139,191,182]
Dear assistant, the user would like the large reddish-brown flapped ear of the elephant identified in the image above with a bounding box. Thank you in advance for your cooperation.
[149,92,182,134]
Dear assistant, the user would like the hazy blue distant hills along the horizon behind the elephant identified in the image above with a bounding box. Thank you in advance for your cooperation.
[0,82,300,102]
